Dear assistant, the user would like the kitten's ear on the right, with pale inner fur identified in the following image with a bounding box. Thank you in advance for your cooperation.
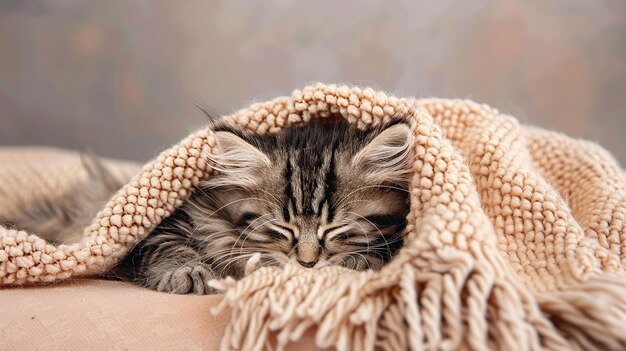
[352,123,413,183]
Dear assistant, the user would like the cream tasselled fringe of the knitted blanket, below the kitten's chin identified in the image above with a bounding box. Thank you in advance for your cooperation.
[211,245,626,350]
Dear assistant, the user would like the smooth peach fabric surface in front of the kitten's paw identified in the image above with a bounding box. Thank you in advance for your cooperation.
[0,279,316,351]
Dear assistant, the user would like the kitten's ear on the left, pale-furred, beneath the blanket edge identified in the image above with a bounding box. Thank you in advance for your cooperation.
[212,132,272,176]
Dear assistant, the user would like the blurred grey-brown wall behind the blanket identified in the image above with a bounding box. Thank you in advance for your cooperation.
[0,0,626,165]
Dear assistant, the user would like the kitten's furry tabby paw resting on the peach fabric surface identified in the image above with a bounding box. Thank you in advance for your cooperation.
[156,263,215,295]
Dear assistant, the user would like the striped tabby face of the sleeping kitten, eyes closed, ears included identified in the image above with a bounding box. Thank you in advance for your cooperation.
[186,122,411,276]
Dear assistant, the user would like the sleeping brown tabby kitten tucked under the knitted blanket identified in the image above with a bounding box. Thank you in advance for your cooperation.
[6,116,412,294]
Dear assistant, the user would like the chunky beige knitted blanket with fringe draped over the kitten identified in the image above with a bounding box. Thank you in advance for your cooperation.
[0,84,626,350]
